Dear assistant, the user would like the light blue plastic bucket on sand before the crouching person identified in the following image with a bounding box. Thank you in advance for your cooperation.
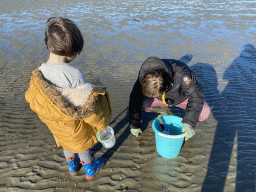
[152,115,187,159]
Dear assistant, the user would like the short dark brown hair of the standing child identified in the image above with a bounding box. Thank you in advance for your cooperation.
[45,17,84,57]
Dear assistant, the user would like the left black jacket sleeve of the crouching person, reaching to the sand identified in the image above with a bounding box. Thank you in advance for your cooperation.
[129,79,144,128]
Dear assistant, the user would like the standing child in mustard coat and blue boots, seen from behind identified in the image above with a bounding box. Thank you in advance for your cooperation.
[25,18,111,179]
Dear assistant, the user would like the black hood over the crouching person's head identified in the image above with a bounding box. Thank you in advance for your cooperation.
[139,57,173,82]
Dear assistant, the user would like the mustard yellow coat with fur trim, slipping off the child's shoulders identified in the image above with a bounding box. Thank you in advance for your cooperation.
[25,70,112,153]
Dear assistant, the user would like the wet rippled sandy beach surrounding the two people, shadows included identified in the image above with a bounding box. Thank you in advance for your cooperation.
[0,0,256,192]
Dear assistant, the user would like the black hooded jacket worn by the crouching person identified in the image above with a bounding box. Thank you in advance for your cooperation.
[129,57,204,128]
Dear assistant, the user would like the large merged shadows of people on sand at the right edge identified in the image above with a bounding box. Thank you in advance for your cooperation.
[191,44,256,192]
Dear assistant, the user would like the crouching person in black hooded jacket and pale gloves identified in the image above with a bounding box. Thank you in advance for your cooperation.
[129,57,210,141]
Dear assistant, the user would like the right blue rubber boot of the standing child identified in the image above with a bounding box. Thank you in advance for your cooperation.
[80,157,105,180]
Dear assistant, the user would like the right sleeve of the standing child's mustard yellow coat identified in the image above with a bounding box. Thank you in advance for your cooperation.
[84,91,112,131]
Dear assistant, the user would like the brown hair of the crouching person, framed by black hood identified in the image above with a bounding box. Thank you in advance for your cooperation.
[141,69,172,97]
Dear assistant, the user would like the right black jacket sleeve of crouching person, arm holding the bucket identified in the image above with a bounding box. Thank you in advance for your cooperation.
[181,75,204,127]
